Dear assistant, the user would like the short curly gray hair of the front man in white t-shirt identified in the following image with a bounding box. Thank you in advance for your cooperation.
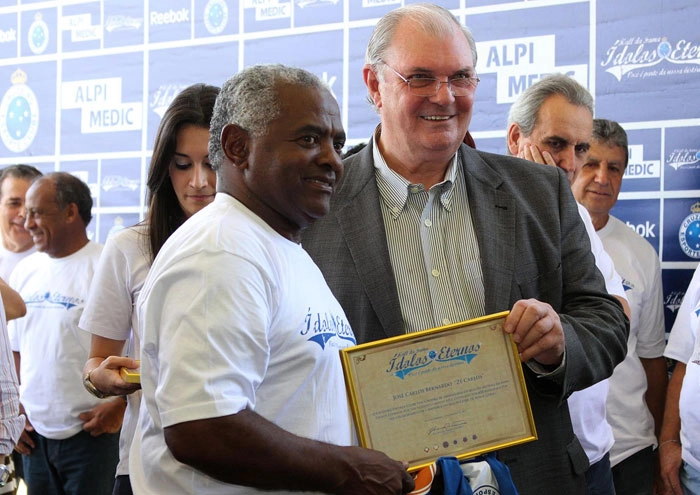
[209,64,328,170]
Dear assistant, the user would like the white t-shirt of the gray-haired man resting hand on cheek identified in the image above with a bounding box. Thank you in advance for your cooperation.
[568,204,627,464]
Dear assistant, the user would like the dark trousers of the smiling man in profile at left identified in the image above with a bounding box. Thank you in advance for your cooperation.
[24,431,119,495]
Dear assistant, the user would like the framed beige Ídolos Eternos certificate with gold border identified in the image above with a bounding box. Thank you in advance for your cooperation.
[341,311,537,471]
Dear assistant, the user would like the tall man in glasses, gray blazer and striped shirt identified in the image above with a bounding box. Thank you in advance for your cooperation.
[303,4,628,495]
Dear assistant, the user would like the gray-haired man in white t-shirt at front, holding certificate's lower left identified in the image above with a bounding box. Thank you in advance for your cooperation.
[129,65,414,495]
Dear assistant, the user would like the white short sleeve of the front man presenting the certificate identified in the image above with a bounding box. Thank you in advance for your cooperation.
[137,251,272,427]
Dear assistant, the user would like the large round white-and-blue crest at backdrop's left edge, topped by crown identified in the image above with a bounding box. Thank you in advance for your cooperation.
[0,69,39,153]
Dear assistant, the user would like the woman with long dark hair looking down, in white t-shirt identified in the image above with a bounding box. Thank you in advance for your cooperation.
[80,84,219,495]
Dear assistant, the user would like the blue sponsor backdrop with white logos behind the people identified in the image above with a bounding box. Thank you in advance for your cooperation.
[0,0,700,334]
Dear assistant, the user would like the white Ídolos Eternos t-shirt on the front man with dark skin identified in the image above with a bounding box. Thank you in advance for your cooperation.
[129,193,355,495]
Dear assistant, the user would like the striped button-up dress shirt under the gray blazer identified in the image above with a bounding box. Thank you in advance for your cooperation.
[374,146,485,333]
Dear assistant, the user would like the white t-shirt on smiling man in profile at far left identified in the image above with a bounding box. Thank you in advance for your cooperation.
[8,242,102,440]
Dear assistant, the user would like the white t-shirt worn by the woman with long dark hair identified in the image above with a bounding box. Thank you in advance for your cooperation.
[79,225,150,475]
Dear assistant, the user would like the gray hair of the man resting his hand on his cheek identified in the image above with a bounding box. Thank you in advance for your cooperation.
[506,74,593,139]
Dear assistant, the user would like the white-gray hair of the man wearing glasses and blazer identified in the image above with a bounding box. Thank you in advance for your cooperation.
[365,3,476,110]
